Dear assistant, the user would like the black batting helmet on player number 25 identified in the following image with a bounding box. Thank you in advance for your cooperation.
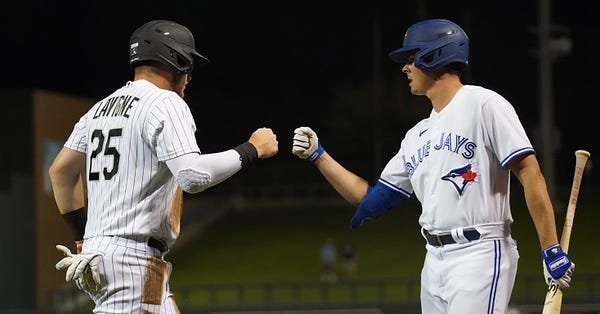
[129,20,208,74]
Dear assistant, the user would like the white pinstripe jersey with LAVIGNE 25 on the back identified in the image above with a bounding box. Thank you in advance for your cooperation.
[64,80,200,246]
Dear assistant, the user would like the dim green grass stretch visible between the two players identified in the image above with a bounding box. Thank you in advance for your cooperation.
[168,199,424,284]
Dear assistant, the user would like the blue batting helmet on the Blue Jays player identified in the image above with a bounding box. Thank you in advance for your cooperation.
[389,19,469,72]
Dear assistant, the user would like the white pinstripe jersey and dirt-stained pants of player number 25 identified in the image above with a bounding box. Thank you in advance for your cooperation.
[65,80,200,314]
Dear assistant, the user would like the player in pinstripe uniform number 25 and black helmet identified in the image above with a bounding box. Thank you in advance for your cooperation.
[49,20,278,313]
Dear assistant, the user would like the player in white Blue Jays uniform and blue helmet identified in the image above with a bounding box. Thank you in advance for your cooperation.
[292,19,574,314]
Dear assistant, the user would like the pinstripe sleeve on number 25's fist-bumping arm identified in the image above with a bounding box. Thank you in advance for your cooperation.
[146,95,200,161]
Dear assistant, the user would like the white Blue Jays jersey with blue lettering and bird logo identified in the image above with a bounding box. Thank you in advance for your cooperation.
[381,85,535,232]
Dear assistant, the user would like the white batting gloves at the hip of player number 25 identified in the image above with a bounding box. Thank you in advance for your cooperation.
[56,245,104,295]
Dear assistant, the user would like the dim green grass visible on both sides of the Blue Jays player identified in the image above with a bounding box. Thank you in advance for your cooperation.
[167,185,600,285]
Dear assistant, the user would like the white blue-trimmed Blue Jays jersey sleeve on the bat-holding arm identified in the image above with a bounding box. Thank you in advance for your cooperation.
[482,95,535,168]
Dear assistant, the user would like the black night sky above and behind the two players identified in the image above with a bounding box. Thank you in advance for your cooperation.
[0,0,600,185]
